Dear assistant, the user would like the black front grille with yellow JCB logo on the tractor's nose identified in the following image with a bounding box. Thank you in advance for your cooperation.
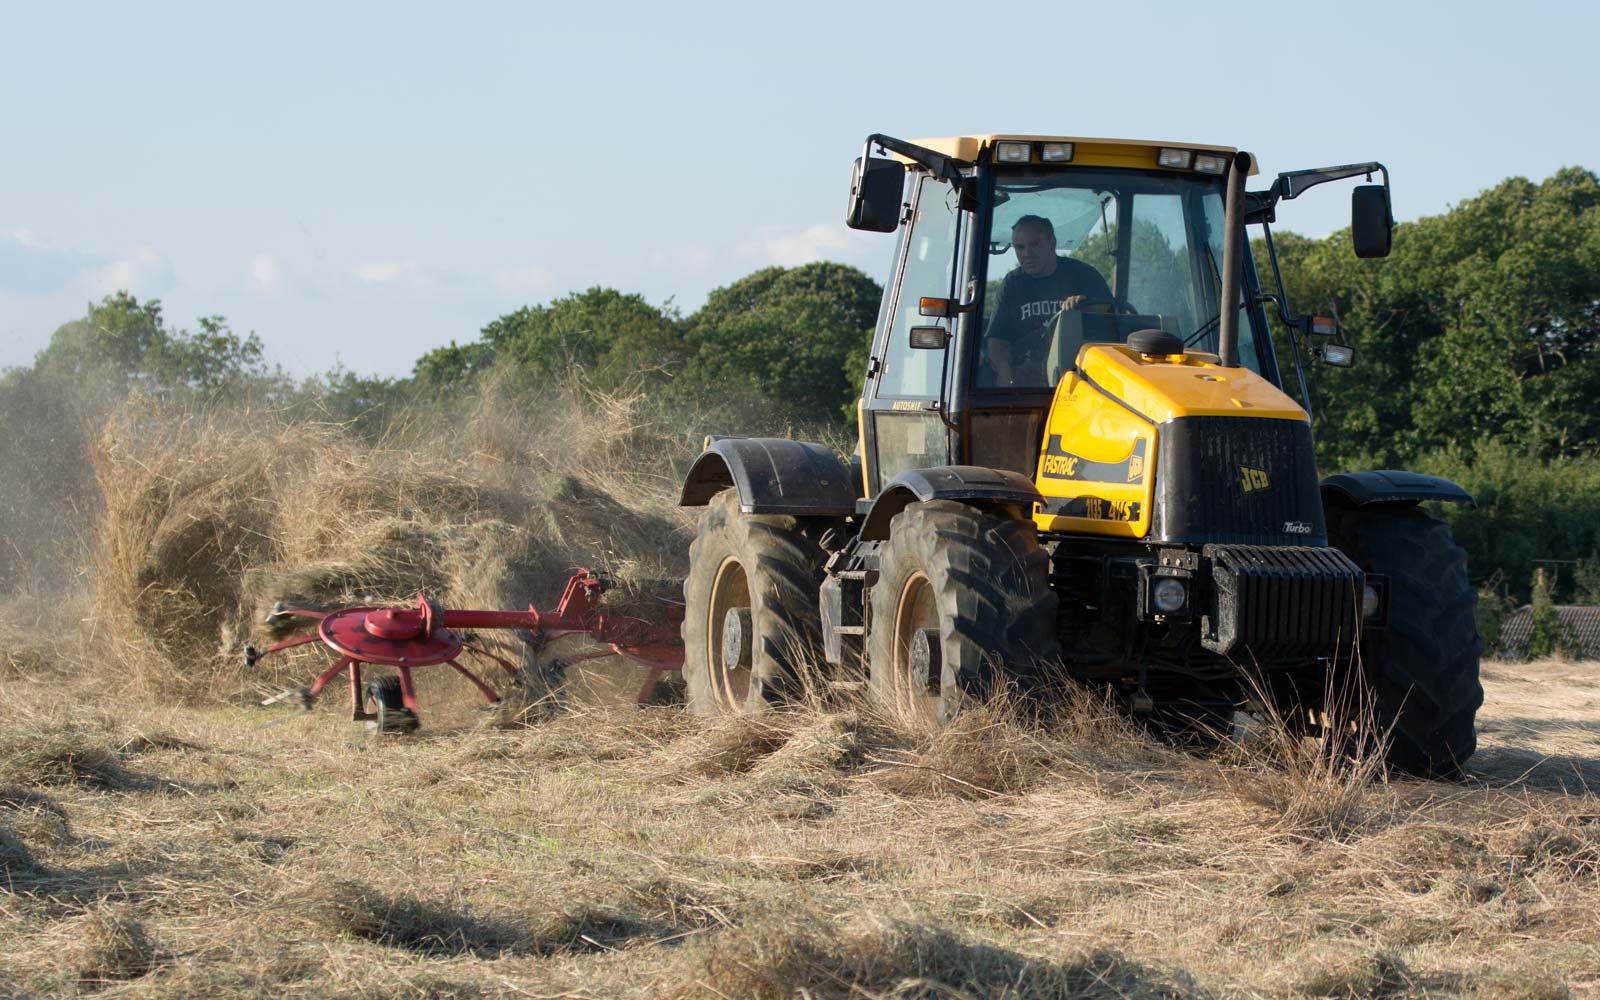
[1152,416,1328,546]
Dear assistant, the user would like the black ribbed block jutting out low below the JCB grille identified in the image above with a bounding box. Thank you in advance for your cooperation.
[1202,546,1365,658]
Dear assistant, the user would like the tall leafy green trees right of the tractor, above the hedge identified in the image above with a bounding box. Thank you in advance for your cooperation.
[1258,168,1600,469]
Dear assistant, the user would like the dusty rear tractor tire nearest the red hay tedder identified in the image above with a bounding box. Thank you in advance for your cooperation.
[683,490,827,717]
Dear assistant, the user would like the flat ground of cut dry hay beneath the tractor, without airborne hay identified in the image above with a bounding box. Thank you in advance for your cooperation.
[0,652,1600,998]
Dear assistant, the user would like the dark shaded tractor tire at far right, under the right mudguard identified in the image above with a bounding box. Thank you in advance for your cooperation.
[1328,507,1483,778]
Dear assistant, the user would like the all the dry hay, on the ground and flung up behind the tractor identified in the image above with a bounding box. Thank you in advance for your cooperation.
[0,393,1600,1000]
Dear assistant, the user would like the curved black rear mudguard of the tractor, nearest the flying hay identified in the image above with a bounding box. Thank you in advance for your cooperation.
[678,437,859,517]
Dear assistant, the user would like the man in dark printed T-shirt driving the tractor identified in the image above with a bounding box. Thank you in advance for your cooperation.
[984,216,1112,386]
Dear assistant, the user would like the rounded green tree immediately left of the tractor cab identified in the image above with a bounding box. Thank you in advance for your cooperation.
[677,262,883,421]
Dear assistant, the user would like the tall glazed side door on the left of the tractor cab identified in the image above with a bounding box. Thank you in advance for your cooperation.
[861,173,970,498]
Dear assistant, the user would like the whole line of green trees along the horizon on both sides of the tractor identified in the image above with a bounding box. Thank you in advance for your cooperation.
[0,168,1600,617]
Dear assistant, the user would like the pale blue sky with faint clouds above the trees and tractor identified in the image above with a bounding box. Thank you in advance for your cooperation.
[0,0,1600,374]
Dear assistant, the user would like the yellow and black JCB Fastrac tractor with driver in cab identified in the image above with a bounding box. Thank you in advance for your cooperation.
[682,134,1483,776]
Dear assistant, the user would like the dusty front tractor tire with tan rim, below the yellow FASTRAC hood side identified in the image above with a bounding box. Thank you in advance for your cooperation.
[867,501,1058,725]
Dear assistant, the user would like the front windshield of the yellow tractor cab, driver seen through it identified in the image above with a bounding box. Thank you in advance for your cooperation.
[976,168,1261,389]
